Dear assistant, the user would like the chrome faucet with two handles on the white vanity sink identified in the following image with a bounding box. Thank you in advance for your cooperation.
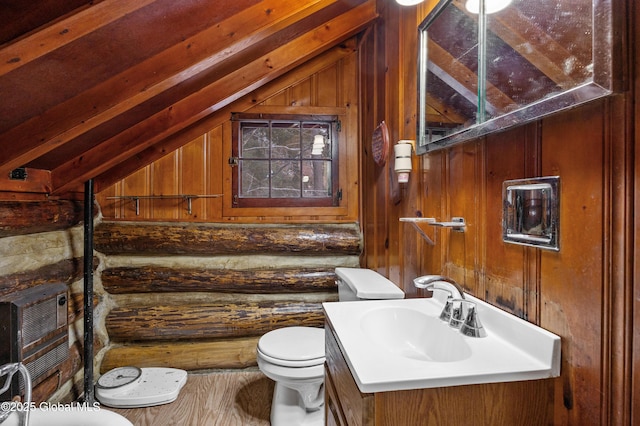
[413,275,487,337]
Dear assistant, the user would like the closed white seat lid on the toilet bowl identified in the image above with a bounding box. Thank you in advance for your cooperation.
[258,327,324,361]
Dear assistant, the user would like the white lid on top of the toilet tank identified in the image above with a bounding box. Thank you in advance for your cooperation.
[336,267,404,299]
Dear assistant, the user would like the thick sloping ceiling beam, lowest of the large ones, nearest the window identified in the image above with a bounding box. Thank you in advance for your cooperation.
[52,1,377,193]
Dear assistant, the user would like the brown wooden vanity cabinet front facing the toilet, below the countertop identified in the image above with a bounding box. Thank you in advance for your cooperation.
[325,324,375,426]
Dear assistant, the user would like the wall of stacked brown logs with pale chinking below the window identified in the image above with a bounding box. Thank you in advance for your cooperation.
[95,222,361,372]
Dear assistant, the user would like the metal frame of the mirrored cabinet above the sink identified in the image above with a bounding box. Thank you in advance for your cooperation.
[416,0,626,154]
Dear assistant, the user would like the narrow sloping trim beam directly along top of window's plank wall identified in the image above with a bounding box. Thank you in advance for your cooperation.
[93,39,356,192]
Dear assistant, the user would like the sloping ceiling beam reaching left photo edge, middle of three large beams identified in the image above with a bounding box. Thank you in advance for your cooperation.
[0,0,337,173]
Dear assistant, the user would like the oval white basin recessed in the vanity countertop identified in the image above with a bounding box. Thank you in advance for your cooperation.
[361,306,471,362]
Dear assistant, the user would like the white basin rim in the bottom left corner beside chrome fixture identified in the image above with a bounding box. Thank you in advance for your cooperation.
[2,405,133,426]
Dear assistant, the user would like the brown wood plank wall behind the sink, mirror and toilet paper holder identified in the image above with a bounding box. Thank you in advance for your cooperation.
[360,1,638,425]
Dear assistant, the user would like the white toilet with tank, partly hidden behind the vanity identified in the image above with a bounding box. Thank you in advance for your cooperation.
[258,268,404,426]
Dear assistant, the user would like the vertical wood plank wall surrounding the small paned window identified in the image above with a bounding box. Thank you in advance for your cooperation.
[96,39,359,222]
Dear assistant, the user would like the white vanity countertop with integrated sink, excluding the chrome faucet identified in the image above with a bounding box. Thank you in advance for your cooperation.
[323,292,560,393]
